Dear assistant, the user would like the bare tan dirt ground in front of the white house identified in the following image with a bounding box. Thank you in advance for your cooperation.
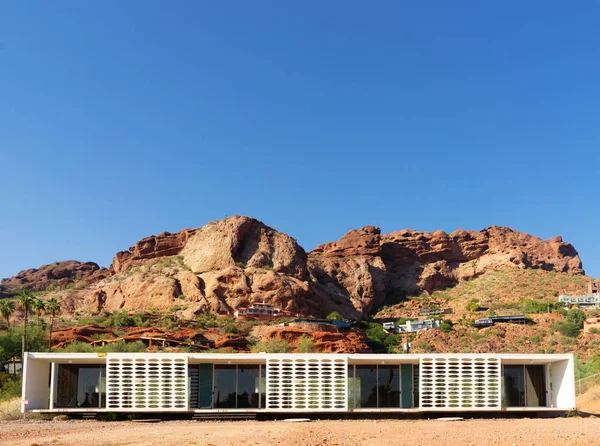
[0,417,600,446]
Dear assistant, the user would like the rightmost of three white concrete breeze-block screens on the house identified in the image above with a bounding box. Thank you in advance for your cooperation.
[419,355,500,410]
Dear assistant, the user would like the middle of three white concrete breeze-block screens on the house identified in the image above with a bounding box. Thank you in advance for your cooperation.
[267,355,348,412]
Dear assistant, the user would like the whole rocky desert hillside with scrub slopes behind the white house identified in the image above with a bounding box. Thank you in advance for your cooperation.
[0,216,600,356]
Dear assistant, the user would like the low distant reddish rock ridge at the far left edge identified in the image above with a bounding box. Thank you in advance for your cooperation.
[2,260,108,293]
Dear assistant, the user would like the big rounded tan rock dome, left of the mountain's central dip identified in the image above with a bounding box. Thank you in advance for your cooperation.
[82,216,322,318]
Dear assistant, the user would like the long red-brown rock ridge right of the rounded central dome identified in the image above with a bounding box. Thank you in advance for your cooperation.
[309,226,584,308]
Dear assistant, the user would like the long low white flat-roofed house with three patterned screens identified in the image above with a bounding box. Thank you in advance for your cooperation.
[22,353,575,416]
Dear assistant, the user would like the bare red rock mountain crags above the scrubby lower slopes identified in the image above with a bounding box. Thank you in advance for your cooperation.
[2,216,584,318]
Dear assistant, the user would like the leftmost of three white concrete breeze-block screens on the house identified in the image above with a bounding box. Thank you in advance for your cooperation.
[106,354,188,411]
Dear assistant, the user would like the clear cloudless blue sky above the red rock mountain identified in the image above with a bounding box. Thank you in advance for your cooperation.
[0,0,600,277]
